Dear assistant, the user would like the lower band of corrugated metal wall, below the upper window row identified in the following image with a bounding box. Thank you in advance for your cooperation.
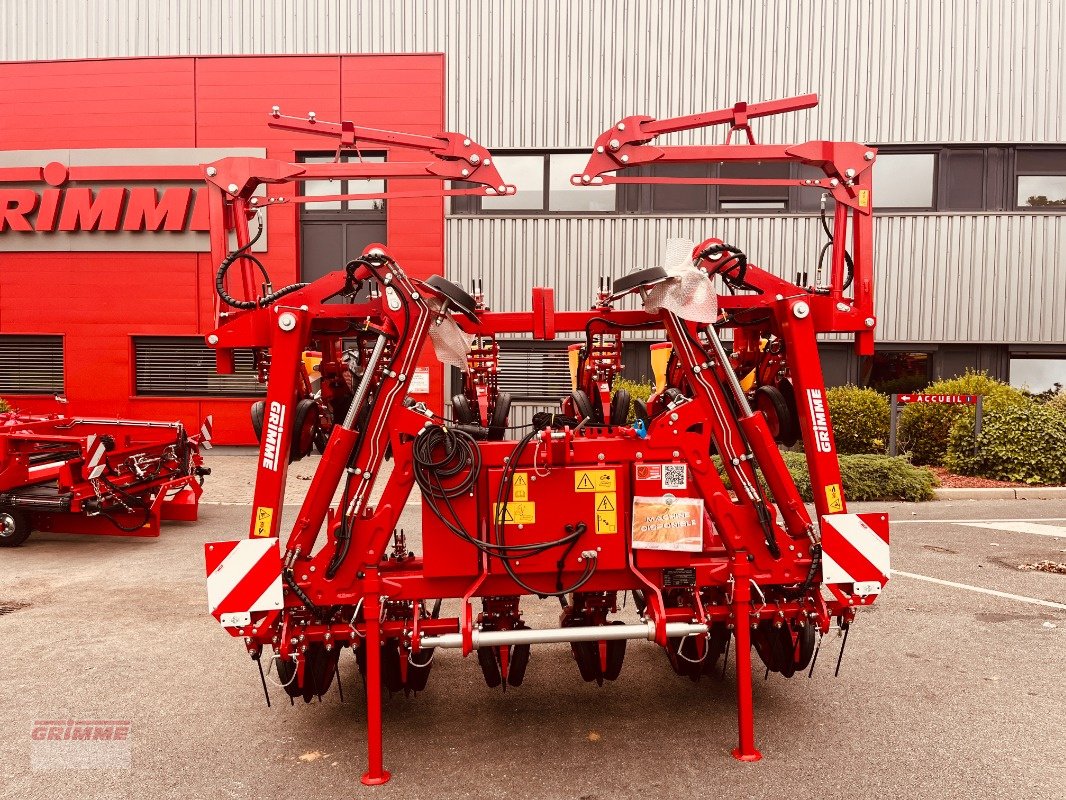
[446,213,1066,342]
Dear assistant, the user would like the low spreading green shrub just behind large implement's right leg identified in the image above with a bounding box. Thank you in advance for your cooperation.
[715,451,939,502]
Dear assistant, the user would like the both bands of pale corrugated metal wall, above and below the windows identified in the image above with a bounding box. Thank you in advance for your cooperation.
[6,0,1066,342]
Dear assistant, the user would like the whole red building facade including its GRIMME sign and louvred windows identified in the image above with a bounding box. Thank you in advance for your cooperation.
[0,54,445,444]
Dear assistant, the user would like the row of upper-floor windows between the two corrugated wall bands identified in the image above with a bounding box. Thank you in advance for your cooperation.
[452,145,1066,215]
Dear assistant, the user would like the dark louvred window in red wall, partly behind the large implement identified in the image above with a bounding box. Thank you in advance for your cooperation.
[133,336,267,397]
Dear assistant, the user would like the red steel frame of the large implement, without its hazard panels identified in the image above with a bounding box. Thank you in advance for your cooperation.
[208,96,887,784]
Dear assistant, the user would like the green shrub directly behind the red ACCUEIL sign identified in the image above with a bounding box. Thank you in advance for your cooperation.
[899,371,1033,465]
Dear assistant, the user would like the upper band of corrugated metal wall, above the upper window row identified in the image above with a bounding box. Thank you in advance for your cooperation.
[0,0,1066,147]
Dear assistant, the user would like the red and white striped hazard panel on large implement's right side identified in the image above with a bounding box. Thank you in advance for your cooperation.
[822,514,889,596]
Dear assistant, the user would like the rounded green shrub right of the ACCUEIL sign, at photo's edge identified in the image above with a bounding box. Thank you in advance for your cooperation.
[944,403,1066,483]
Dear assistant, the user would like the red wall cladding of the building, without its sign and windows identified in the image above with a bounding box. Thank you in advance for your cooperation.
[0,54,445,444]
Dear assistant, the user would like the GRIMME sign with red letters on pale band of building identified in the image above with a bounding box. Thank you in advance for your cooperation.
[0,148,265,252]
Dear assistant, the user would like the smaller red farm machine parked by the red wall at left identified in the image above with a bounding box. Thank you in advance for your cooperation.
[0,412,211,547]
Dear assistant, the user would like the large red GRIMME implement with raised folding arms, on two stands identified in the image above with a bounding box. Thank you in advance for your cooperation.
[206,96,888,784]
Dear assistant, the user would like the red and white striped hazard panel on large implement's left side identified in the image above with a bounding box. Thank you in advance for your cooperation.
[204,539,285,627]
